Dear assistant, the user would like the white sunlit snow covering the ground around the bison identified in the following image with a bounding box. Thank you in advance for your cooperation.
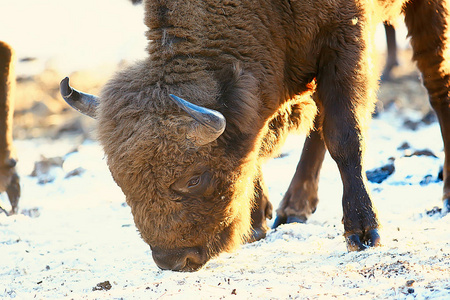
[0,106,450,299]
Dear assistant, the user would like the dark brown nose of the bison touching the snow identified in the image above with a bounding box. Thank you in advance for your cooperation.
[151,247,209,272]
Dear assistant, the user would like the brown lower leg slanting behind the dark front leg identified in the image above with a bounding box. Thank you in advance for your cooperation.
[273,126,326,228]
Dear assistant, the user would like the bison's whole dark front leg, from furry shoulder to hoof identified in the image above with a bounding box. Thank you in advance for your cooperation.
[317,34,380,251]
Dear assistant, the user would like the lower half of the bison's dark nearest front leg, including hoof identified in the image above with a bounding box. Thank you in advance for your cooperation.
[323,106,380,251]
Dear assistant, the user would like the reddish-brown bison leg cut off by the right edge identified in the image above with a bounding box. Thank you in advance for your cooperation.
[405,0,450,212]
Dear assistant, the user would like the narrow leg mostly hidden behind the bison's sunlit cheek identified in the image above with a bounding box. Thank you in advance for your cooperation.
[247,171,272,243]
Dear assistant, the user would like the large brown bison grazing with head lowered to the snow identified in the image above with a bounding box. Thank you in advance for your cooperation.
[61,0,450,271]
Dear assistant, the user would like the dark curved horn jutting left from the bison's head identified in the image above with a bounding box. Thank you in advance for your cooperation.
[59,77,99,119]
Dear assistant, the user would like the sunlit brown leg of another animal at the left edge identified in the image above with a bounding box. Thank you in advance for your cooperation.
[0,41,20,214]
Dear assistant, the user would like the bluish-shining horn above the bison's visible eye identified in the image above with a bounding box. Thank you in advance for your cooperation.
[170,94,226,145]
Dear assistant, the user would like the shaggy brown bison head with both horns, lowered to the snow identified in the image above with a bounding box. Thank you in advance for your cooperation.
[61,67,258,271]
